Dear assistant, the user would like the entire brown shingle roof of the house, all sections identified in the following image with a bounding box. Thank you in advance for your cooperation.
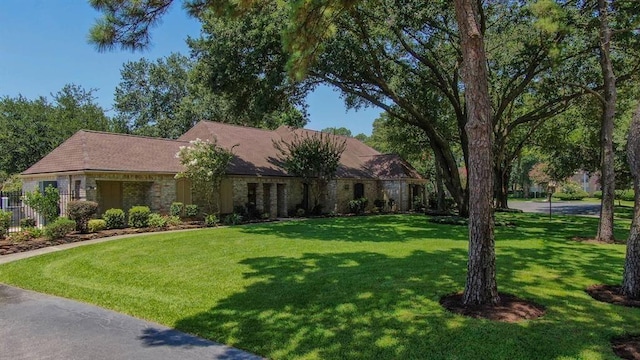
[22,121,421,183]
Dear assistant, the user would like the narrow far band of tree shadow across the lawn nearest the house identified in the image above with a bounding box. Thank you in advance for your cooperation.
[240,213,630,242]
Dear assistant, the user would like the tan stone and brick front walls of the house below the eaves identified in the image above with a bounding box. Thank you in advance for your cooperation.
[23,173,422,218]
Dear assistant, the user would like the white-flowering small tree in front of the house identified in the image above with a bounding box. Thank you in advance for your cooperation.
[176,139,235,214]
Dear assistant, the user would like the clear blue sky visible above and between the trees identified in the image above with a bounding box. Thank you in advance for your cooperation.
[0,0,380,135]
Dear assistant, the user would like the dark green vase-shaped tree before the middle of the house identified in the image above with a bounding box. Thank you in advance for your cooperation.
[273,132,347,212]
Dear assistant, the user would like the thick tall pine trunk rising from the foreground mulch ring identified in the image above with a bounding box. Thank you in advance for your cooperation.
[455,0,500,306]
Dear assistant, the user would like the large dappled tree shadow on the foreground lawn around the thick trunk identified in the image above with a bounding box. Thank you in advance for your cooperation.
[175,244,640,359]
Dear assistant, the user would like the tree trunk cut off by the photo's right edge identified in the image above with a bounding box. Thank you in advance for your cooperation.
[622,102,640,299]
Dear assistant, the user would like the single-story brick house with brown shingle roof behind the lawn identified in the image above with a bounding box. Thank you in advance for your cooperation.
[22,121,425,217]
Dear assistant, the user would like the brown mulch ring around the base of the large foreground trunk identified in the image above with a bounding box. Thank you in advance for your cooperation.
[440,293,546,323]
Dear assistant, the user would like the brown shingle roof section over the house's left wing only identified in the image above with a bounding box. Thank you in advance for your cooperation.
[22,130,188,175]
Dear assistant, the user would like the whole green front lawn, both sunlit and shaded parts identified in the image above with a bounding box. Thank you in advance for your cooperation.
[0,214,640,359]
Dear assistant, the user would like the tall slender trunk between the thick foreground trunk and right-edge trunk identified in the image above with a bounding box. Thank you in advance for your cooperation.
[596,0,617,243]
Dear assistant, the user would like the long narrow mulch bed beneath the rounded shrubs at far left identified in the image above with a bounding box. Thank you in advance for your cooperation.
[0,222,204,256]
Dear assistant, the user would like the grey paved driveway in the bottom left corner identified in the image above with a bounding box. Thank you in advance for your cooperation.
[0,284,260,360]
